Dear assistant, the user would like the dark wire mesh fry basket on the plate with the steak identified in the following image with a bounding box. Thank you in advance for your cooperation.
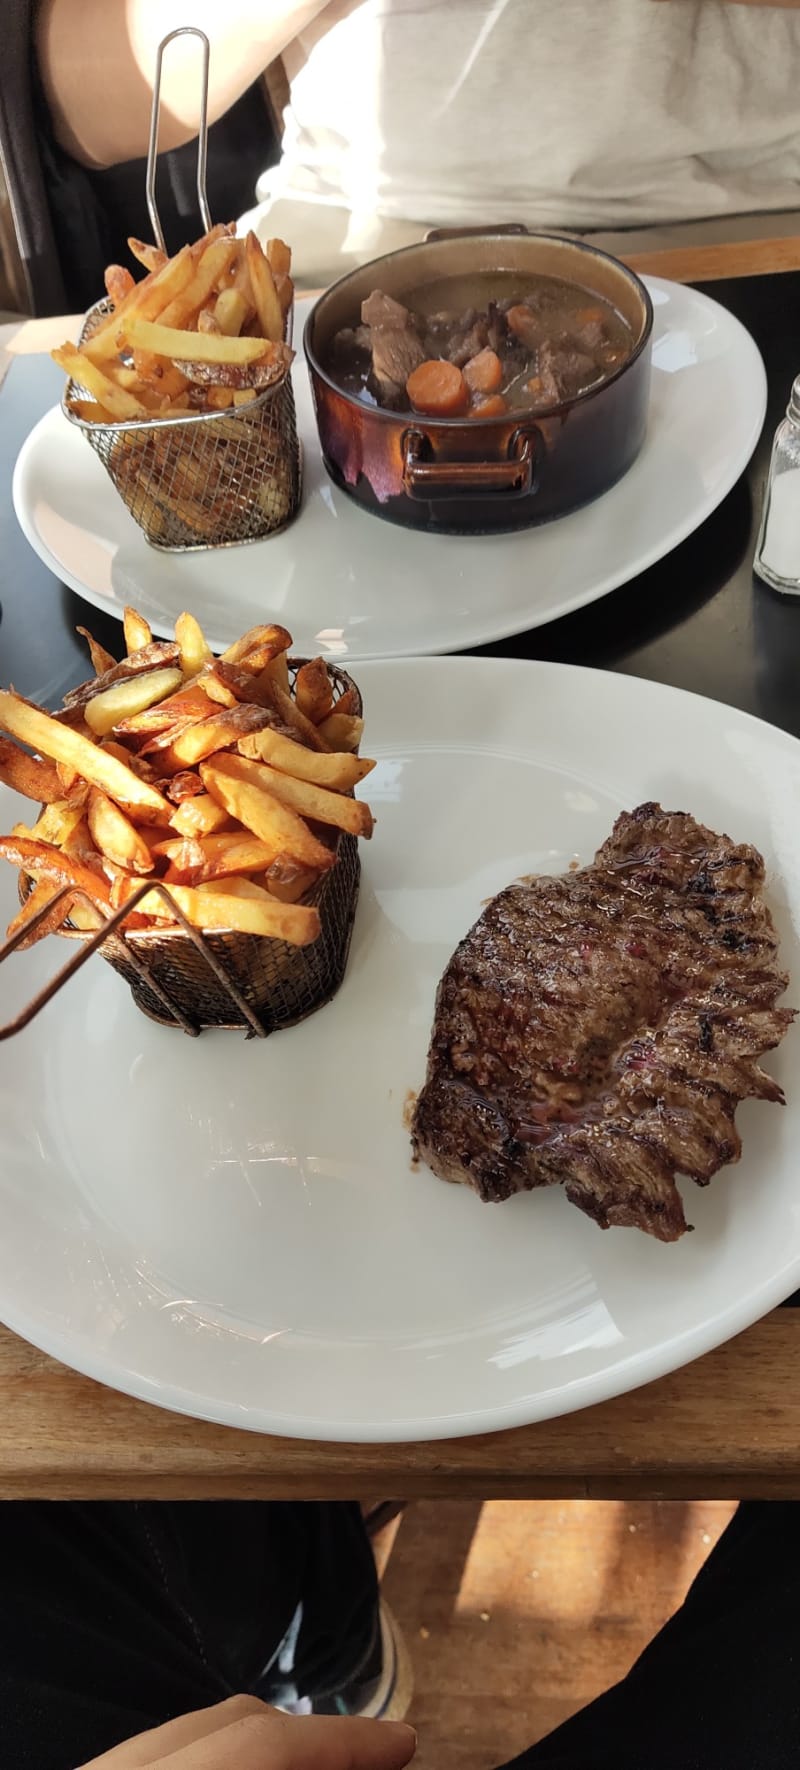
[0,658,361,1039]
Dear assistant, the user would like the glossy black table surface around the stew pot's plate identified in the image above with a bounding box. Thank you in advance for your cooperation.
[0,273,800,736]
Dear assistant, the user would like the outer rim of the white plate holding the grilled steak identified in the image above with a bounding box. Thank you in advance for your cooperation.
[0,655,800,1444]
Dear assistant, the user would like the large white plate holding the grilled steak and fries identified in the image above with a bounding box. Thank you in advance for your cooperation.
[0,658,800,1441]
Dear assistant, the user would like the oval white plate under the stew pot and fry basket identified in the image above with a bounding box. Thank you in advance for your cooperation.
[14,278,766,658]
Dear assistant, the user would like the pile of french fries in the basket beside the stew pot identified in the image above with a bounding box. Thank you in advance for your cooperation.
[51,223,294,425]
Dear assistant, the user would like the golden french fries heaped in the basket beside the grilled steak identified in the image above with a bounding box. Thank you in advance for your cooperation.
[0,609,375,947]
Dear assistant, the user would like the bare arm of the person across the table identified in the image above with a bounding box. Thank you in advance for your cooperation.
[35,0,327,166]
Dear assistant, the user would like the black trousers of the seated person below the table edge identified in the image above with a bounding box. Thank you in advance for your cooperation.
[0,1503,800,1770]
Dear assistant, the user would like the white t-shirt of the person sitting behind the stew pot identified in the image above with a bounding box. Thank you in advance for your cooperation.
[240,0,800,280]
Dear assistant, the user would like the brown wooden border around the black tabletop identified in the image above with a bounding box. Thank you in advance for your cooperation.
[0,235,800,1499]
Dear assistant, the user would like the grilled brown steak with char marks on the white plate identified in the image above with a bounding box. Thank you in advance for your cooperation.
[412,804,793,1241]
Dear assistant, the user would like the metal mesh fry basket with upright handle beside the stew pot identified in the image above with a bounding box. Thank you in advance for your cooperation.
[62,27,303,552]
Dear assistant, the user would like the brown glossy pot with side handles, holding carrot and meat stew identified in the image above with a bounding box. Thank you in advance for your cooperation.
[303,232,653,535]
